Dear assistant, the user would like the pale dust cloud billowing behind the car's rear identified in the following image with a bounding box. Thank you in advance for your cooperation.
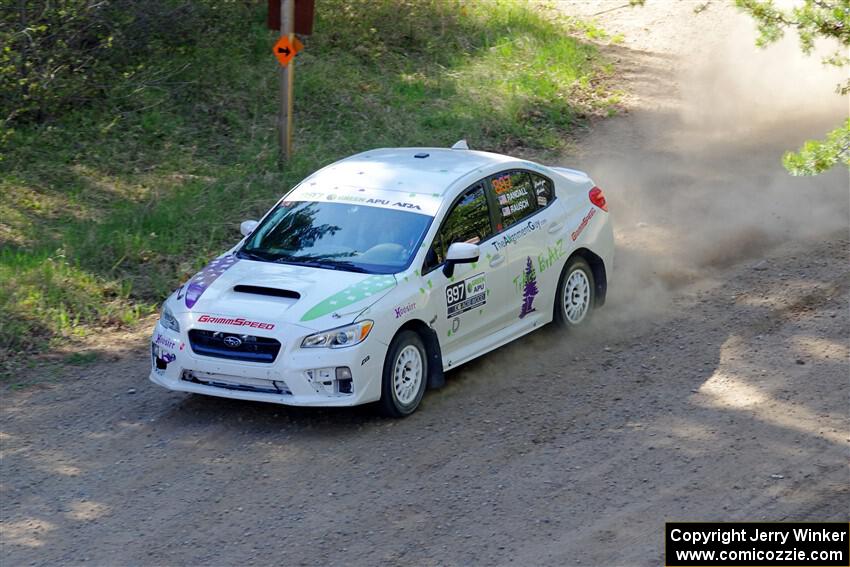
[564,4,850,325]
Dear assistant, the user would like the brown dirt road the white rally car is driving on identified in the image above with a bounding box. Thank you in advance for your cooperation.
[0,0,850,566]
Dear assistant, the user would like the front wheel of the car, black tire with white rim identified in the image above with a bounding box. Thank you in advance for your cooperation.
[381,331,428,417]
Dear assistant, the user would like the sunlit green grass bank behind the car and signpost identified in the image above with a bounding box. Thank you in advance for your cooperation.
[0,0,616,364]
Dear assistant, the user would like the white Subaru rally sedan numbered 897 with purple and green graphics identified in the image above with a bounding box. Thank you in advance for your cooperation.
[150,141,614,416]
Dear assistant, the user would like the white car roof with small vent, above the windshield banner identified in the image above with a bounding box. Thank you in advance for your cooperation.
[303,148,517,197]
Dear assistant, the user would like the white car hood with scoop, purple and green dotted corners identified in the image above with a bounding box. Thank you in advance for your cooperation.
[174,254,396,330]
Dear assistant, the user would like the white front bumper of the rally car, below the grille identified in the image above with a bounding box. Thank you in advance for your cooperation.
[150,322,387,407]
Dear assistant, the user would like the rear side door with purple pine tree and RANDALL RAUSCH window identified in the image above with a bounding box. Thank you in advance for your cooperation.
[480,169,565,325]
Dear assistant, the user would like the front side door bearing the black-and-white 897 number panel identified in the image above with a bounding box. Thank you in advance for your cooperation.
[422,181,512,354]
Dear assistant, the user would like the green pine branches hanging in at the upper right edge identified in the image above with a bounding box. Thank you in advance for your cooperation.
[735,0,850,175]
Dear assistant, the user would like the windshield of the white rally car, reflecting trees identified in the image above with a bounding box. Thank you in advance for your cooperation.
[238,201,431,274]
